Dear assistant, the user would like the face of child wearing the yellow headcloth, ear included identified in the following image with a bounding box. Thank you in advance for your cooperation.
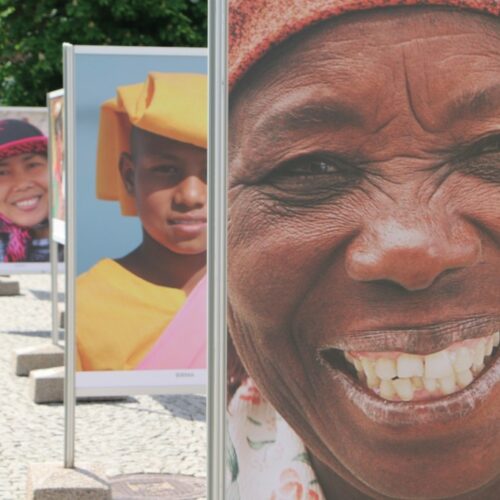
[120,129,207,255]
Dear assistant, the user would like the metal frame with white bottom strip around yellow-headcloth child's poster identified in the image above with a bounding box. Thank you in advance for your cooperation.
[63,44,210,468]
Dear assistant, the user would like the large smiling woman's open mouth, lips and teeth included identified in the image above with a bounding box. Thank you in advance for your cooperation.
[319,316,500,425]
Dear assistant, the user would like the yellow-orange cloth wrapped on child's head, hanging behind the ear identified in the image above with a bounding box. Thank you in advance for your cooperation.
[96,73,208,215]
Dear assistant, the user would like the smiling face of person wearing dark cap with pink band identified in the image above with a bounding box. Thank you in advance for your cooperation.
[0,153,49,227]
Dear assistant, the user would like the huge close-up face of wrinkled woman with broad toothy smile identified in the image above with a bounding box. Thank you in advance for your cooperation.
[228,8,500,498]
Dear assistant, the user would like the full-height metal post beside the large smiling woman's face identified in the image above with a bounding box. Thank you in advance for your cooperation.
[207,0,227,500]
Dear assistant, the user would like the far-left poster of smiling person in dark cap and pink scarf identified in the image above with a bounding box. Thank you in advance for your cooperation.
[0,107,50,274]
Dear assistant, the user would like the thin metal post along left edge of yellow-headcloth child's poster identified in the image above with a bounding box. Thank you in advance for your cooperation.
[63,43,76,468]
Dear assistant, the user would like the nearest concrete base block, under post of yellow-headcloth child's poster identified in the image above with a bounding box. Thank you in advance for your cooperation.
[26,463,111,500]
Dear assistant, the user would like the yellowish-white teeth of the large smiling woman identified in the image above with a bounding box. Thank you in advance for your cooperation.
[344,332,500,401]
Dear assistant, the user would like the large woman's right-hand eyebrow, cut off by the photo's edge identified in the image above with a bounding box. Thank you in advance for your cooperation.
[448,83,500,121]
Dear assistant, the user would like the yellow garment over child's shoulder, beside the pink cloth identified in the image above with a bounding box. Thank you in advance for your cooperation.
[76,259,186,370]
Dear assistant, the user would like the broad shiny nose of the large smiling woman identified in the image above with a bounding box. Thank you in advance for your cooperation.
[346,215,481,291]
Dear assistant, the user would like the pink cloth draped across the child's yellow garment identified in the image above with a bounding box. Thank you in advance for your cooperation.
[136,275,207,370]
